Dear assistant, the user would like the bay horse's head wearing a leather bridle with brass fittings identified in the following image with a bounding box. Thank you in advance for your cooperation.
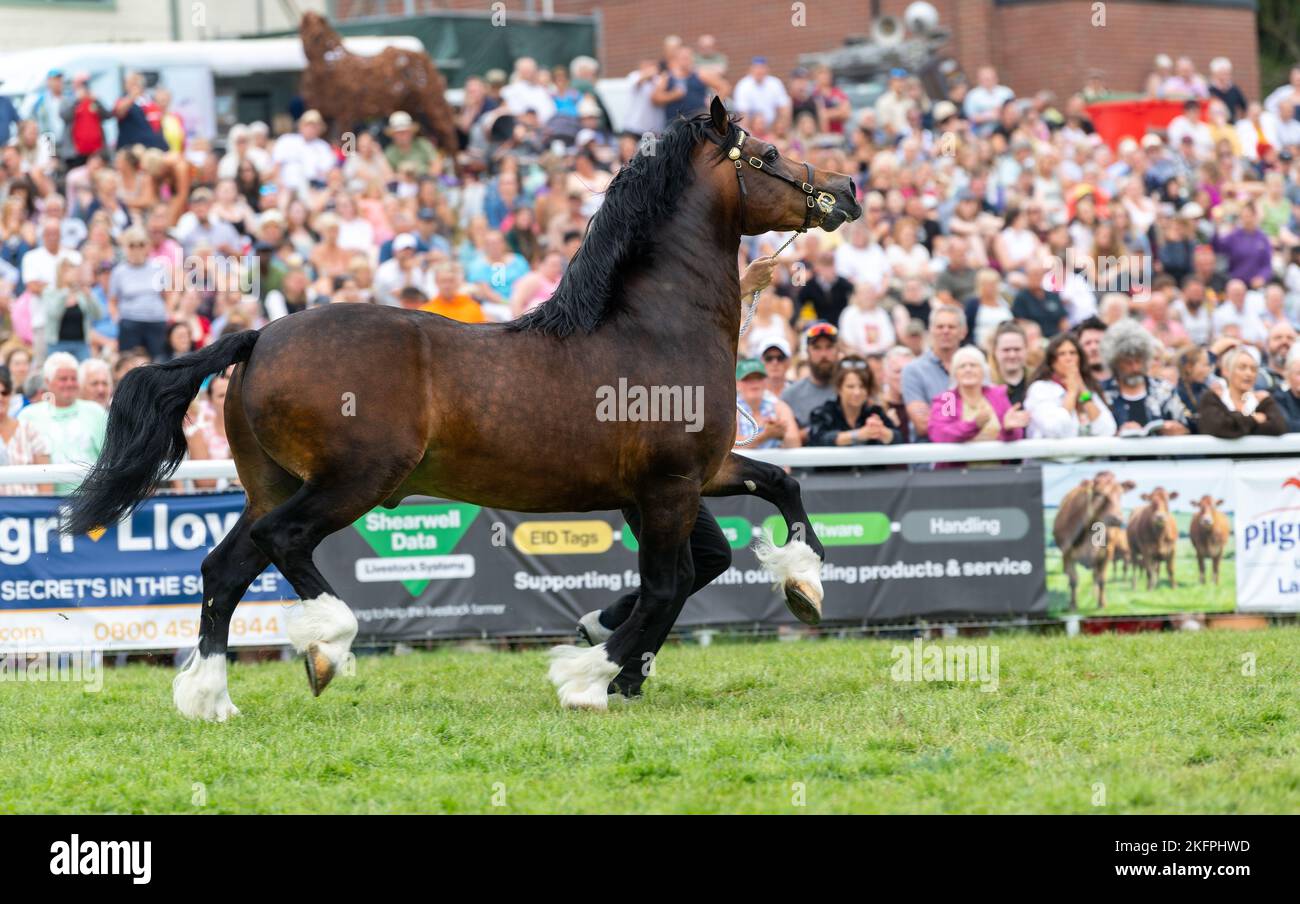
[709,98,862,235]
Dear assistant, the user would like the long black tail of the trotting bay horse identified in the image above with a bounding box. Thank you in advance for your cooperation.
[60,329,257,535]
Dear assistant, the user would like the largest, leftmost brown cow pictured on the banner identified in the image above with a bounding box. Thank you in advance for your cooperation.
[1052,471,1135,611]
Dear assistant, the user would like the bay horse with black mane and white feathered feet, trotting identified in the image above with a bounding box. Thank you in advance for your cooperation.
[61,100,862,721]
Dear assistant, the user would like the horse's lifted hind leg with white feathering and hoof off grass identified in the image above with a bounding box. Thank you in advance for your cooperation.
[252,475,394,696]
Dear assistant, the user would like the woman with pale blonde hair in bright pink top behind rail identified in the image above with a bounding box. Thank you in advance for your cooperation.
[930,346,1030,467]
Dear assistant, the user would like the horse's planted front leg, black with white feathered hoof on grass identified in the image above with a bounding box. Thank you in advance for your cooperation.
[550,477,699,709]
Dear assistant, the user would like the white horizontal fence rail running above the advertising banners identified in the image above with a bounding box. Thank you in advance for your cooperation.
[0,433,1300,484]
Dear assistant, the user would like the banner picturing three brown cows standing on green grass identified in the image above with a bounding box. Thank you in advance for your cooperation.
[1043,459,1232,615]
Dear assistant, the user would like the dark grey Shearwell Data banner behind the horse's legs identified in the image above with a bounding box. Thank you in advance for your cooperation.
[316,467,1047,639]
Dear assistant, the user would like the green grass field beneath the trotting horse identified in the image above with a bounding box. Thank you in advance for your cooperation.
[0,628,1300,813]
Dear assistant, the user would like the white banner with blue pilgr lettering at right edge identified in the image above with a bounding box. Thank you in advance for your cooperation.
[1235,459,1300,613]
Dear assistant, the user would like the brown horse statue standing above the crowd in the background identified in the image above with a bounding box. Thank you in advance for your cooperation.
[298,13,460,157]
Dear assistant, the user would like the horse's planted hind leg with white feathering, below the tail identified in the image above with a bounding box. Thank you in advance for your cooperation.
[172,510,270,722]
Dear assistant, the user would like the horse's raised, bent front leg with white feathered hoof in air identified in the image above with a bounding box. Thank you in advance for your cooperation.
[702,453,826,624]
